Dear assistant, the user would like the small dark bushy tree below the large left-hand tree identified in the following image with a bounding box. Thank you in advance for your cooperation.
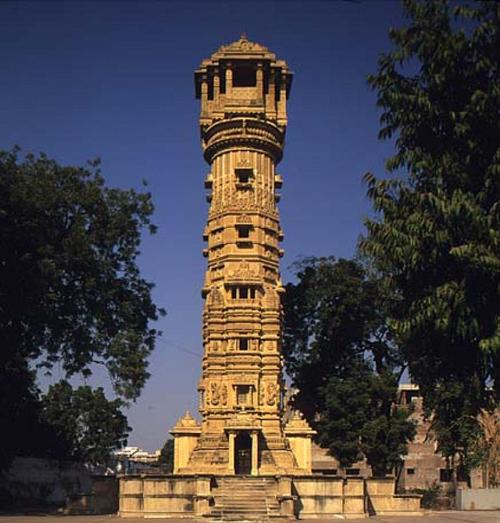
[41,381,131,465]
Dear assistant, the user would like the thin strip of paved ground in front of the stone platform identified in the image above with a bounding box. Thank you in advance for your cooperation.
[0,510,500,523]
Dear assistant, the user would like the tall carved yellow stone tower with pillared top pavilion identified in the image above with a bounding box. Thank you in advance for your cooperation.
[172,36,314,475]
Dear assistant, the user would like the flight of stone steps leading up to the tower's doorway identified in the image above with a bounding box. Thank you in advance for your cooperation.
[212,476,279,521]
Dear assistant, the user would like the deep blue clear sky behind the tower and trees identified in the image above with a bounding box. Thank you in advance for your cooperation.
[0,0,402,450]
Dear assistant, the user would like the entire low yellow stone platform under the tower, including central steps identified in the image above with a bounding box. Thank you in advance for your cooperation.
[119,475,421,521]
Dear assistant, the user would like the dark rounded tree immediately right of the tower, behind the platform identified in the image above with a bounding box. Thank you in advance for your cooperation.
[283,258,415,475]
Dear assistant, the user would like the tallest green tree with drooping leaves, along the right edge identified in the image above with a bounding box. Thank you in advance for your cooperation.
[361,0,500,474]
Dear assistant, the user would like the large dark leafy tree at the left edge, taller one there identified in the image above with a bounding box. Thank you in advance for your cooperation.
[0,149,162,467]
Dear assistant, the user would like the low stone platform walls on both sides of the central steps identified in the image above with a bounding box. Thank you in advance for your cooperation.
[119,475,422,519]
